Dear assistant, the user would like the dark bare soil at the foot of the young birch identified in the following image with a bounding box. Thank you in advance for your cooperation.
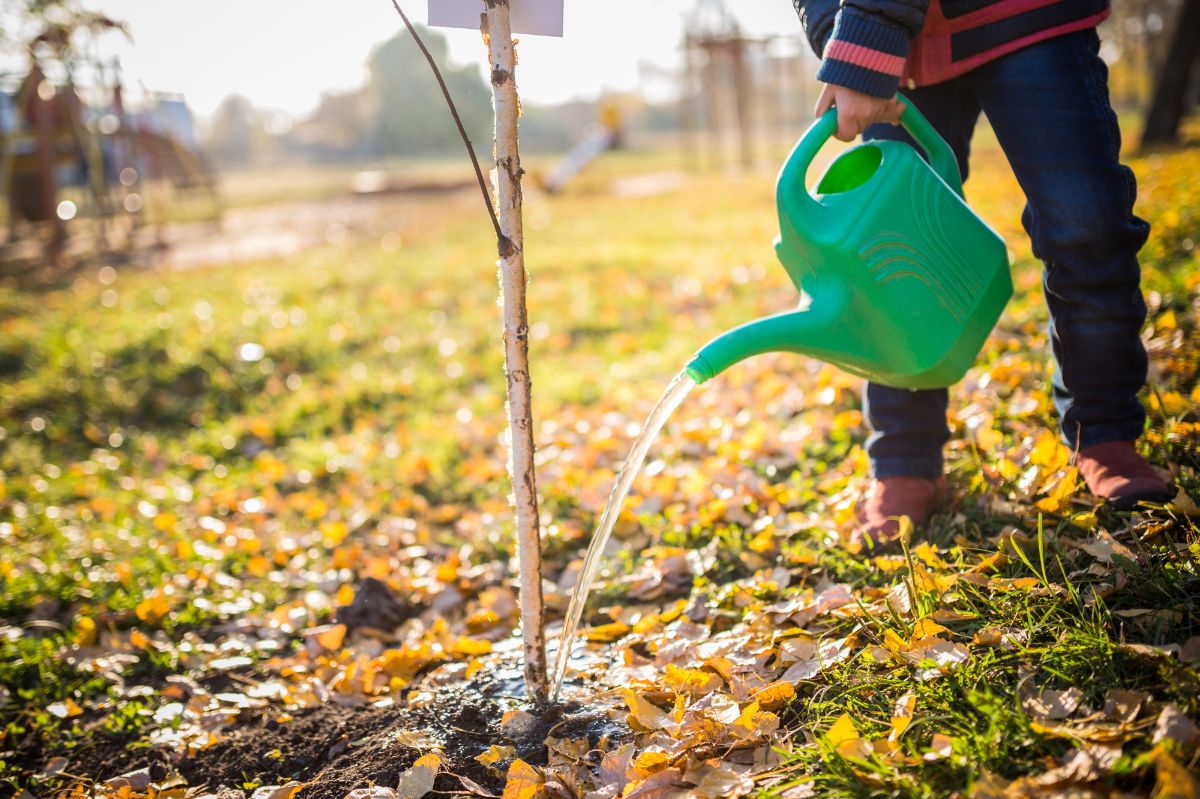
[59,657,628,799]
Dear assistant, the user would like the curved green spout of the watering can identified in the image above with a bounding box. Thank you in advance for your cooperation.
[686,287,869,383]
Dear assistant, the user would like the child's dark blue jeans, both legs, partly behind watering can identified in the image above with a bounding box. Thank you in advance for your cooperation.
[864,30,1150,477]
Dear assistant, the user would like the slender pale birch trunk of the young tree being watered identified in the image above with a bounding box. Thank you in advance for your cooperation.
[484,0,550,704]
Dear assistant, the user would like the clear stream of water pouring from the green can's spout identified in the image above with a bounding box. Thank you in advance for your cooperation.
[551,372,696,699]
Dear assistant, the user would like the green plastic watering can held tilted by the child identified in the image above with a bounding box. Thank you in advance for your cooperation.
[688,97,1013,389]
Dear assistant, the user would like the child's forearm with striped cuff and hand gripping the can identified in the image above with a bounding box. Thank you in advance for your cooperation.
[792,0,929,142]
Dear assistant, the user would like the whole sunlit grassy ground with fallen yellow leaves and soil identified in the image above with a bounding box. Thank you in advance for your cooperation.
[0,130,1200,799]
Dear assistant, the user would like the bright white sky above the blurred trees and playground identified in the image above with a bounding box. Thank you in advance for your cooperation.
[68,0,799,116]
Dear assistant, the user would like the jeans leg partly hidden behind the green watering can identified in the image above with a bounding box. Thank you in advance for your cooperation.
[863,82,979,479]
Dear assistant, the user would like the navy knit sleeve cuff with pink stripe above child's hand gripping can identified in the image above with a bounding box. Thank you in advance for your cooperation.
[817,6,911,97]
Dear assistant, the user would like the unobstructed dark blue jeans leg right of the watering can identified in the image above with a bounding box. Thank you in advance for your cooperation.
[964,30,1150,449]
